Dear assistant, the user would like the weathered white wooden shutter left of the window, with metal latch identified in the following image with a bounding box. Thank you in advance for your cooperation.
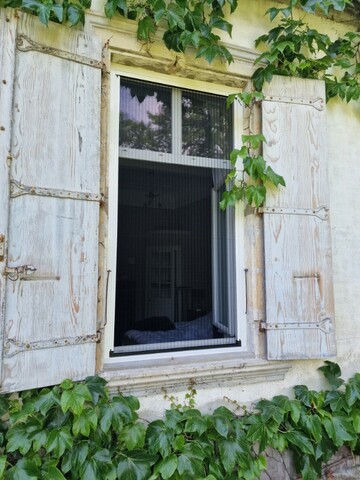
[0,11,101,391]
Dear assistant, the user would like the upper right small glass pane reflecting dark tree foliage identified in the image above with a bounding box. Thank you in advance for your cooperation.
[181,91,233,159]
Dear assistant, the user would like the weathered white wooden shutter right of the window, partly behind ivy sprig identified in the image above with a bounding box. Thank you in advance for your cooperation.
[262,77,336,359]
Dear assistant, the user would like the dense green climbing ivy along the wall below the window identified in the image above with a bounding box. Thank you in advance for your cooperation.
[0,362,360,480]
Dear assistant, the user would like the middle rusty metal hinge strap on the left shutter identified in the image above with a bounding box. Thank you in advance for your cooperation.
[10,180,103,202]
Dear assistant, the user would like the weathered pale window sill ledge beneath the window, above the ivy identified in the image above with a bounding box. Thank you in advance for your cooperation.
[101,352,291,396]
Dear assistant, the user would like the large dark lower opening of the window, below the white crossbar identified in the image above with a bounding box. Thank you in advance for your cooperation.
[115,159,235,353]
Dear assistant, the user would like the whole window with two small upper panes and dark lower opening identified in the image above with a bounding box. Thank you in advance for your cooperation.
[109,75,244,355]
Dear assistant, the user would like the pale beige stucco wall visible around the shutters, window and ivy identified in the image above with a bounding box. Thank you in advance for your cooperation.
[87,0,360,418]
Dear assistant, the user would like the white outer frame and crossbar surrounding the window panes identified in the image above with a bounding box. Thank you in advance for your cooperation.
[103,65,248,367]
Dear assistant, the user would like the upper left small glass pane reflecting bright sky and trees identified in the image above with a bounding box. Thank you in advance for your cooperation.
[119,78,171,153]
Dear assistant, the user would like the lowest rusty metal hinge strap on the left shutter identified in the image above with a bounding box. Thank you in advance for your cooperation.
[4,332,100,358]
